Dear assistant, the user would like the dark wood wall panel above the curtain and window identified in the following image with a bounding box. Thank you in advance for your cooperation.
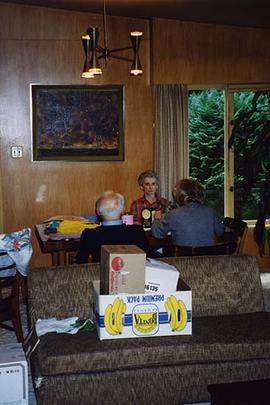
[152,19,270,85]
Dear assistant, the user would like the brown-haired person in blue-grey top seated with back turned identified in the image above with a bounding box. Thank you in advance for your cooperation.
[151,178,224,247]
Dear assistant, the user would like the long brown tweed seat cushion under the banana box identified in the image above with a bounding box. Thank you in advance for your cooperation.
[36,312,270,375]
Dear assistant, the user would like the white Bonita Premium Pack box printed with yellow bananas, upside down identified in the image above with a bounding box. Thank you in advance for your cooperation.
[93,279,192,340]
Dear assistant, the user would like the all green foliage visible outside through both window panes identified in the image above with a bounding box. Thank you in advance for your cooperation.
[189,89,270,255]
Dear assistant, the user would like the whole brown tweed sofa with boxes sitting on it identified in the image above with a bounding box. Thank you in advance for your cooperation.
[28,255,270,405]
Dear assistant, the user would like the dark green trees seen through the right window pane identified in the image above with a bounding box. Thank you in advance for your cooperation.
[229,91,270,220]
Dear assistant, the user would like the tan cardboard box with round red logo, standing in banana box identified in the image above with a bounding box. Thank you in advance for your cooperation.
[100,245,146,294]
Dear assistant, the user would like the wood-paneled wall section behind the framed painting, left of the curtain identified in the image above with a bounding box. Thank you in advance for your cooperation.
[0,3,153,266]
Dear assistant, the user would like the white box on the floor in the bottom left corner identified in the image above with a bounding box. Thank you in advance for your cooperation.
[0,343,28,405]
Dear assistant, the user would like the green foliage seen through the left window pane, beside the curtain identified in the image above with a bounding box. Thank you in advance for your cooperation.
[189,90,224,218]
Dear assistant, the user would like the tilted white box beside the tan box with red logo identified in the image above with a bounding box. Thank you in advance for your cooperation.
[145,259,179,293]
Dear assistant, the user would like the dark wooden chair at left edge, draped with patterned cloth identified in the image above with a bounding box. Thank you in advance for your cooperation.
[0,252,24,342]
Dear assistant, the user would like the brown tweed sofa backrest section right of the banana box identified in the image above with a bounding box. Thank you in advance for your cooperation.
[163,255,264,317]
